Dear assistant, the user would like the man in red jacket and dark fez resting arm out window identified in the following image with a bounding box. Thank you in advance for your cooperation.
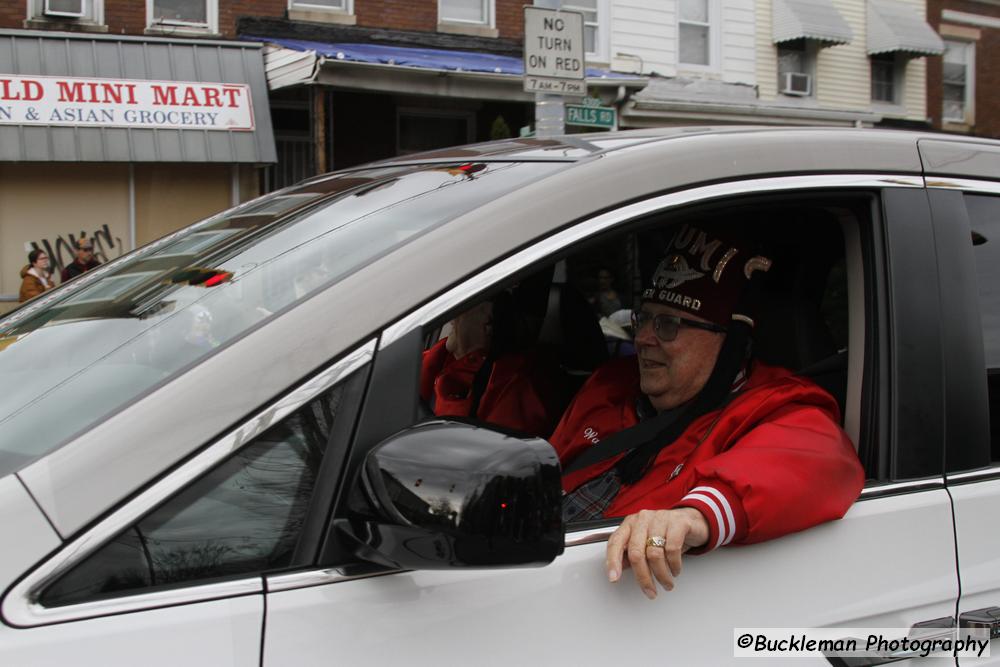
[551,226,864,599]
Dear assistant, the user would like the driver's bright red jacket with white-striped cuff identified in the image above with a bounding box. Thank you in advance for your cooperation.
[551,357,864,551]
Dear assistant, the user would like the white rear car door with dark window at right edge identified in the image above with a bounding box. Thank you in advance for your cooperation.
[930,179,1000,665]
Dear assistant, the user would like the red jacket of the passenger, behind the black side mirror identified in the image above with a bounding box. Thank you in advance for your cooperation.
[420,340,560,438]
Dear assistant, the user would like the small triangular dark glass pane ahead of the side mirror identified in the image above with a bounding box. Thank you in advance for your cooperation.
[41,374,353,607]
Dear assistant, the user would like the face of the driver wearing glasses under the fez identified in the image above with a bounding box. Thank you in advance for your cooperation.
[635,303,726,411]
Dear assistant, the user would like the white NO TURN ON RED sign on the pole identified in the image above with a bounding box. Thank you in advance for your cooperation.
[524,6,587,96]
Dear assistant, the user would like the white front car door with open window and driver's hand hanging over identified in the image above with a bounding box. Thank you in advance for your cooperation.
[263,176,958,667]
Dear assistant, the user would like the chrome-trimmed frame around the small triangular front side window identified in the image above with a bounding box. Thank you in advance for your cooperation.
[0,338,377,628]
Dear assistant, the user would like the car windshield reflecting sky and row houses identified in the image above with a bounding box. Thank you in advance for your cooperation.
[0,162,565,476]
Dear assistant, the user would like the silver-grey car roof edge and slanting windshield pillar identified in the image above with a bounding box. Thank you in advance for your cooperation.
[19,127,1000,537]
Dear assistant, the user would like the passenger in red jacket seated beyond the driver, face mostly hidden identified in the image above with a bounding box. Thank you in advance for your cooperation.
[420,293,561,438]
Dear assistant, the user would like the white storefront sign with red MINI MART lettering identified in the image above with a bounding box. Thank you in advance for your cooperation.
[0,74,254,131]
